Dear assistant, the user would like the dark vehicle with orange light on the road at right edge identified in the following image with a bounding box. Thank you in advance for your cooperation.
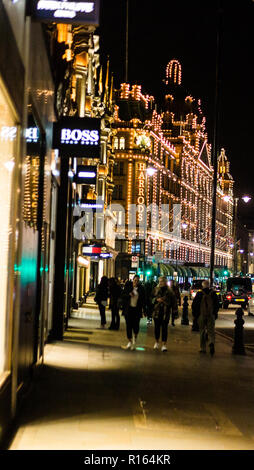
[223,277,253,309]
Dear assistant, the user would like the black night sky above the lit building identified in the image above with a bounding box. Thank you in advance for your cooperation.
[98,0,254,225]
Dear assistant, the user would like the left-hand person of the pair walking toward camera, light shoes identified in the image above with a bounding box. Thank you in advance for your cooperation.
[122,275,145,350]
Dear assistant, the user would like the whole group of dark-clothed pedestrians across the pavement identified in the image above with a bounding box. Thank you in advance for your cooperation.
[94,275,219,356]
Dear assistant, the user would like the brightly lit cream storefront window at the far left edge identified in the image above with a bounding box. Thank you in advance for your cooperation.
[0,80,17,375]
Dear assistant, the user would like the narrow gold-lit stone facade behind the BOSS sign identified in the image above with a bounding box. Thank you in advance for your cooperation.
[53,24,116,316]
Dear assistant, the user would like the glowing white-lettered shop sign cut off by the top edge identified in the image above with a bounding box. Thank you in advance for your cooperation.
[28,0,100,26]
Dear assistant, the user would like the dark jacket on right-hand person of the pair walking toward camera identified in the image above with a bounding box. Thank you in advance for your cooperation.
[153,286,177,320]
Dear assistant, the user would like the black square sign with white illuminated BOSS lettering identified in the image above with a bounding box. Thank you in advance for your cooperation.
[53,116,100,158]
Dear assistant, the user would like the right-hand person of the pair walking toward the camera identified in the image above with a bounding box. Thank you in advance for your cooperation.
[153,276,177,352]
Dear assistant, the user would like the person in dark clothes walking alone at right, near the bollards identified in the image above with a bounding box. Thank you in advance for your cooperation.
[192,281,220,356]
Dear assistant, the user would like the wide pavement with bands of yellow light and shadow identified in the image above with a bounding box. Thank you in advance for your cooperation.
[8,300,254,450]
